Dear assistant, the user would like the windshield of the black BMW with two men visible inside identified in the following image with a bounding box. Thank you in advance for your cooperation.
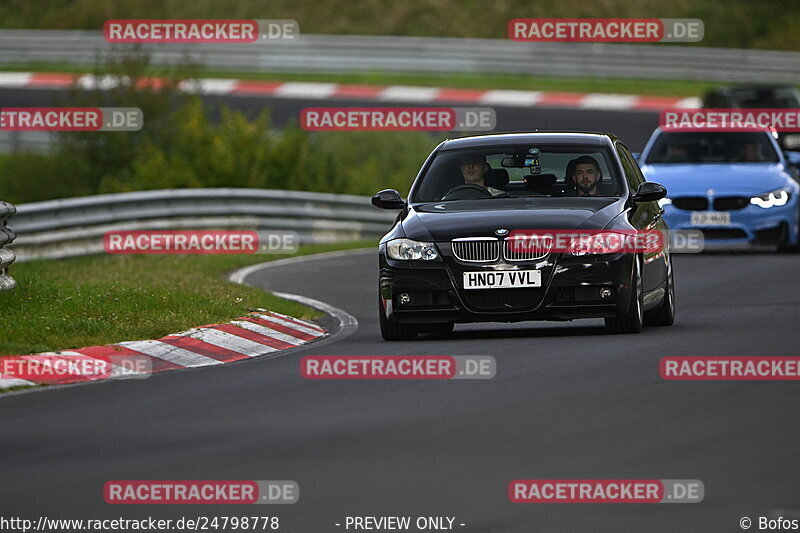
[411,144,622,204]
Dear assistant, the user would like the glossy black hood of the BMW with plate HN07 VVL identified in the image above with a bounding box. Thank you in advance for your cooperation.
[402,198,624,242]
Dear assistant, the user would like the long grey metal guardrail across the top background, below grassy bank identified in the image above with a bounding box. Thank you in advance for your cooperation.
[0,30,800,83]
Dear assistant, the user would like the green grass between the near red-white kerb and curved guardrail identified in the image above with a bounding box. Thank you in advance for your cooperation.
[0,241,375,355]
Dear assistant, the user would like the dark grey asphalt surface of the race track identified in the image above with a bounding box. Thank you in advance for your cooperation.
[0,87,800,533]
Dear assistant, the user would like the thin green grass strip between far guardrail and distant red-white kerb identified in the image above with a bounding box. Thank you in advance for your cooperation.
[0,63,720,96]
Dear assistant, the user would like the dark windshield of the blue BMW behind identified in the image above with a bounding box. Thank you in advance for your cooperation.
[646,132,779,165]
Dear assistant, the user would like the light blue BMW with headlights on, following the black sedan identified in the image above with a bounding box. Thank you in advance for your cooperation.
[638,129,800,252]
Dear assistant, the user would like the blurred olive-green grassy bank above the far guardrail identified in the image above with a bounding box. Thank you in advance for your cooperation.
[0,0,800,50]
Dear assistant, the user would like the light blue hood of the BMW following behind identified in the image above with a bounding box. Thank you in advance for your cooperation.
[642,163,791,196]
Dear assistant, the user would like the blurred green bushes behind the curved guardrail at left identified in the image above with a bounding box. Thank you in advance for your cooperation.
[0,58,438,203]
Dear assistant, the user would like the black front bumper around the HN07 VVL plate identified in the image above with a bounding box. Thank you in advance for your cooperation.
[379,250,635,323]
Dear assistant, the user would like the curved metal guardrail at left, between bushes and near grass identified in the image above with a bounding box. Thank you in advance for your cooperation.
[14,188,396,261]
